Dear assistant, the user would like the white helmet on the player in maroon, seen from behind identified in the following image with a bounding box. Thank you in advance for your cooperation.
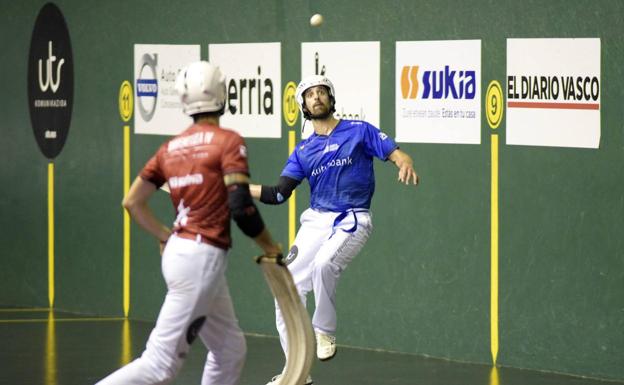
[175,61,225,115]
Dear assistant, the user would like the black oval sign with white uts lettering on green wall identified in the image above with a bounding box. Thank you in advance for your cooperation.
[28,3,74,159]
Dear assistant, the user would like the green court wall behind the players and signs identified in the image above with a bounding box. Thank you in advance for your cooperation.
[0,0,624,380]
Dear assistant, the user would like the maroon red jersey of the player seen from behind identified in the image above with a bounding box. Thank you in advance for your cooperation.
[139,123,249,249]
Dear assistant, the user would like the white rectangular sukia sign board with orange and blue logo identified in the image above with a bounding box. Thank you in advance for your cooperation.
[395,40,481,144]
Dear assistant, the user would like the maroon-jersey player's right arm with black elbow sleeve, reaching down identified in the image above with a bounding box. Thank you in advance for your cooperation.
[223,173,282,254]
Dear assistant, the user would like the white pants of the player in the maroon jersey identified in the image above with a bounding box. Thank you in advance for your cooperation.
[98,235,247,385]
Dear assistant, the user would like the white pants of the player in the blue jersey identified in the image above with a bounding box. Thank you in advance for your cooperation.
[275,209,373,352]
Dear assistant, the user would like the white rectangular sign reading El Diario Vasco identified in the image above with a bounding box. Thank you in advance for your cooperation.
[505,38,601,148]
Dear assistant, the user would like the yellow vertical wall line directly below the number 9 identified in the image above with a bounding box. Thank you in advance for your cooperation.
[490,134,498,365]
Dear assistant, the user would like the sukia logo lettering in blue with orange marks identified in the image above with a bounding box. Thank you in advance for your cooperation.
[401,65,477,99]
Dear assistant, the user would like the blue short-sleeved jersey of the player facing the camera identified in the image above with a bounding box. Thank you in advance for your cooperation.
[282,120,398,212]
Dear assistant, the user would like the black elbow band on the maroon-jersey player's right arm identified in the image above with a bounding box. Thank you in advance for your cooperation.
[228,183,264,238]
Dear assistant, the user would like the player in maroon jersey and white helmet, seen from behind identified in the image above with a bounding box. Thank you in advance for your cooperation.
[98,62,281,385]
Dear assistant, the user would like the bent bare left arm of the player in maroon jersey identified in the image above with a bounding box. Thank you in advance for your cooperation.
[122,177,171,243]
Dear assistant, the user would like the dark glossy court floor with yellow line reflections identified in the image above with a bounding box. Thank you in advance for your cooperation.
[0,309,624,385]
